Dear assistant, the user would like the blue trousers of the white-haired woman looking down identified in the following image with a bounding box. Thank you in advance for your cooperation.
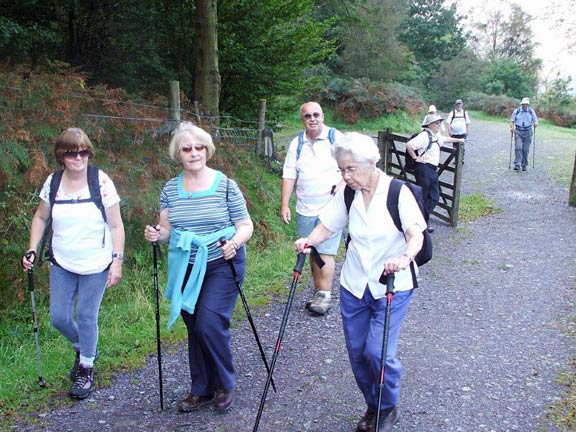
[340,286,414,412]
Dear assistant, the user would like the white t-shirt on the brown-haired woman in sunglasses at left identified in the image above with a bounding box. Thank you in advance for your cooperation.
[40,171,120,275]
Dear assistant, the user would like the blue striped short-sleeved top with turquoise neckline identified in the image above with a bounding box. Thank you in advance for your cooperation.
[160,171,250,263]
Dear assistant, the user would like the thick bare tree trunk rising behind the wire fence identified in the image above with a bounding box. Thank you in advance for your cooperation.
[194,0,220,126]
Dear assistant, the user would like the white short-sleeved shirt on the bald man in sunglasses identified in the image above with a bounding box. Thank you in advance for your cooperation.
[282,125,342,216]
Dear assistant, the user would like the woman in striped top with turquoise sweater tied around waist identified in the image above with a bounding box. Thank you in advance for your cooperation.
[144,122,254,413]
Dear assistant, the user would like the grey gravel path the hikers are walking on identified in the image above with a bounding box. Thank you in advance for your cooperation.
[12,121,576,432]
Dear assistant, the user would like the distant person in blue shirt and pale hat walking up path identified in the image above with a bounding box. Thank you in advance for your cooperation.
[510,97,538,171]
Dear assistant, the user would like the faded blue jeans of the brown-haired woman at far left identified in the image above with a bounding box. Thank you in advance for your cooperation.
[50,265,108,358]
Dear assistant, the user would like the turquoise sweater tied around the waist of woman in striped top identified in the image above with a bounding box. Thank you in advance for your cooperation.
[165,225,236,328]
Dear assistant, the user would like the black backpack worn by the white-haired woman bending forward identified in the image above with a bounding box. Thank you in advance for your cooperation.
[344,179,433,288]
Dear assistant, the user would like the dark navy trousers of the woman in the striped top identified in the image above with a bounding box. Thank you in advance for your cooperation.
[181,247,246,396]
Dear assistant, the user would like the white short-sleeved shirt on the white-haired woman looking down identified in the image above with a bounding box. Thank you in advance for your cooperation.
[320,170,426,299]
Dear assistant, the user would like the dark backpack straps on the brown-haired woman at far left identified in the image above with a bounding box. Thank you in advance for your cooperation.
[38,165,107,266]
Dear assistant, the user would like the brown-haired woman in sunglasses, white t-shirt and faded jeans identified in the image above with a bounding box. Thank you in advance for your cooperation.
[22,128,124,399]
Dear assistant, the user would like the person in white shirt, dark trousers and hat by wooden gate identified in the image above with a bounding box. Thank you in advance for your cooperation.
[406,114,464,233]
